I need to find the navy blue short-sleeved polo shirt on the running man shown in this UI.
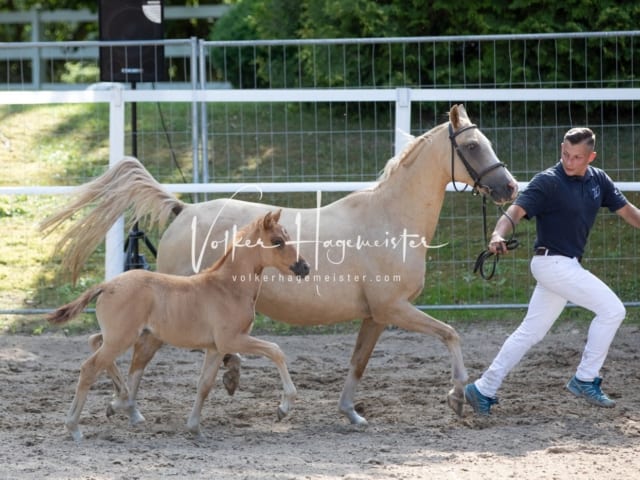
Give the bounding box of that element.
[514,162,627,258]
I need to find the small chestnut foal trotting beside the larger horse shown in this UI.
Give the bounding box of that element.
[48,212,309,441]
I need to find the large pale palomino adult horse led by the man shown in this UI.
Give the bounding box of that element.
[42,105,518,424]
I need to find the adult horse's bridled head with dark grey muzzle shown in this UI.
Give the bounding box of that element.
[449,105,518,204]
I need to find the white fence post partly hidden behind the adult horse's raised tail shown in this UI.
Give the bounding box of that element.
[104,84,125,280]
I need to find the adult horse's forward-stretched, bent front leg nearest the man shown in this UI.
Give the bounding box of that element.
[374,302,469,416]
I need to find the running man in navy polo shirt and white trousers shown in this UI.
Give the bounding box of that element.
[465,128,640,415]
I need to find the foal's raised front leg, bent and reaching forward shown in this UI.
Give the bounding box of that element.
[224,334,297,420]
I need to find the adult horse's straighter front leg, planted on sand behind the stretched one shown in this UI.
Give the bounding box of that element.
[338,318,385,425]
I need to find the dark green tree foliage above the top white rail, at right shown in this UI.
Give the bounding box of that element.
[210,0,640,88]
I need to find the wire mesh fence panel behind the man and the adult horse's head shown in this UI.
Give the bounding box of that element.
[201,32,640,308]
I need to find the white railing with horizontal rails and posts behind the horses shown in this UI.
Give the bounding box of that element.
[0,84,640,284]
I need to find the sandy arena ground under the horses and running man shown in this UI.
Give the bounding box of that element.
[0,322,640,480]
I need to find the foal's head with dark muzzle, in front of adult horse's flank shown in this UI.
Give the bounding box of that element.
[259,210,310,278]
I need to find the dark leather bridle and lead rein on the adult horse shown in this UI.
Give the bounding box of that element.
[449,122,518,280]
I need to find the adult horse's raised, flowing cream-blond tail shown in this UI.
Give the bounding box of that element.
[40,157,185,283]
